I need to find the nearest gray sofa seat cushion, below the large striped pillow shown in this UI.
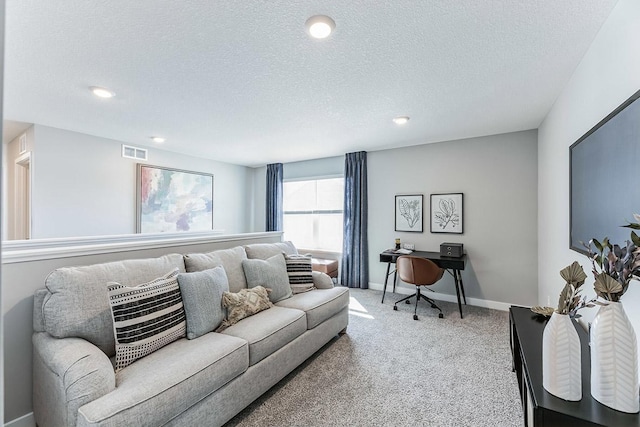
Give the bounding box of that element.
[78,333,249,426]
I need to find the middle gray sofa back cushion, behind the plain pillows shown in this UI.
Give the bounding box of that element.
[184,246,247,292]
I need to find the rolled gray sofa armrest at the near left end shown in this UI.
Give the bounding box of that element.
[32,332,116,427]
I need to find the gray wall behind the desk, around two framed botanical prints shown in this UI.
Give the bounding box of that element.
[367,130,537,306]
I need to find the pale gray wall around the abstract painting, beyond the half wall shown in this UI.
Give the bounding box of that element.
[32,124,252,239]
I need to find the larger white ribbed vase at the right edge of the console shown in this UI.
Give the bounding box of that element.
[591,302,640,414]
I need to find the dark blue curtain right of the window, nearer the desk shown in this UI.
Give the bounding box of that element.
[340,151,369,289]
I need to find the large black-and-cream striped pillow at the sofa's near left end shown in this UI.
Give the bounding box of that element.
[107,268,187,372]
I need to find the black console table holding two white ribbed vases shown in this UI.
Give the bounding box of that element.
[509,306,640,427]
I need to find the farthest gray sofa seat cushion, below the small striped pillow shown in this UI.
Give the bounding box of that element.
[276,286,349,329]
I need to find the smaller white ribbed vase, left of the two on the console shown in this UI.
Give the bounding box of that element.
[542,313,582,401]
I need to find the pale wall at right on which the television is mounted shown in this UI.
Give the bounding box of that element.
[538,0,640,333]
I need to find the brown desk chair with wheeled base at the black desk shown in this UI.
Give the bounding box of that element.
[393,255,444,320]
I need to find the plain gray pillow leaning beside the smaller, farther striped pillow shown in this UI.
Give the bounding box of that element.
[242,254,292,302]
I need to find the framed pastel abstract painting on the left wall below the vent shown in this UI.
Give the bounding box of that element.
[136,164,213,233]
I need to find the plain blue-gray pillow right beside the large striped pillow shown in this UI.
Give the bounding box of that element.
[178,267,229,340]
